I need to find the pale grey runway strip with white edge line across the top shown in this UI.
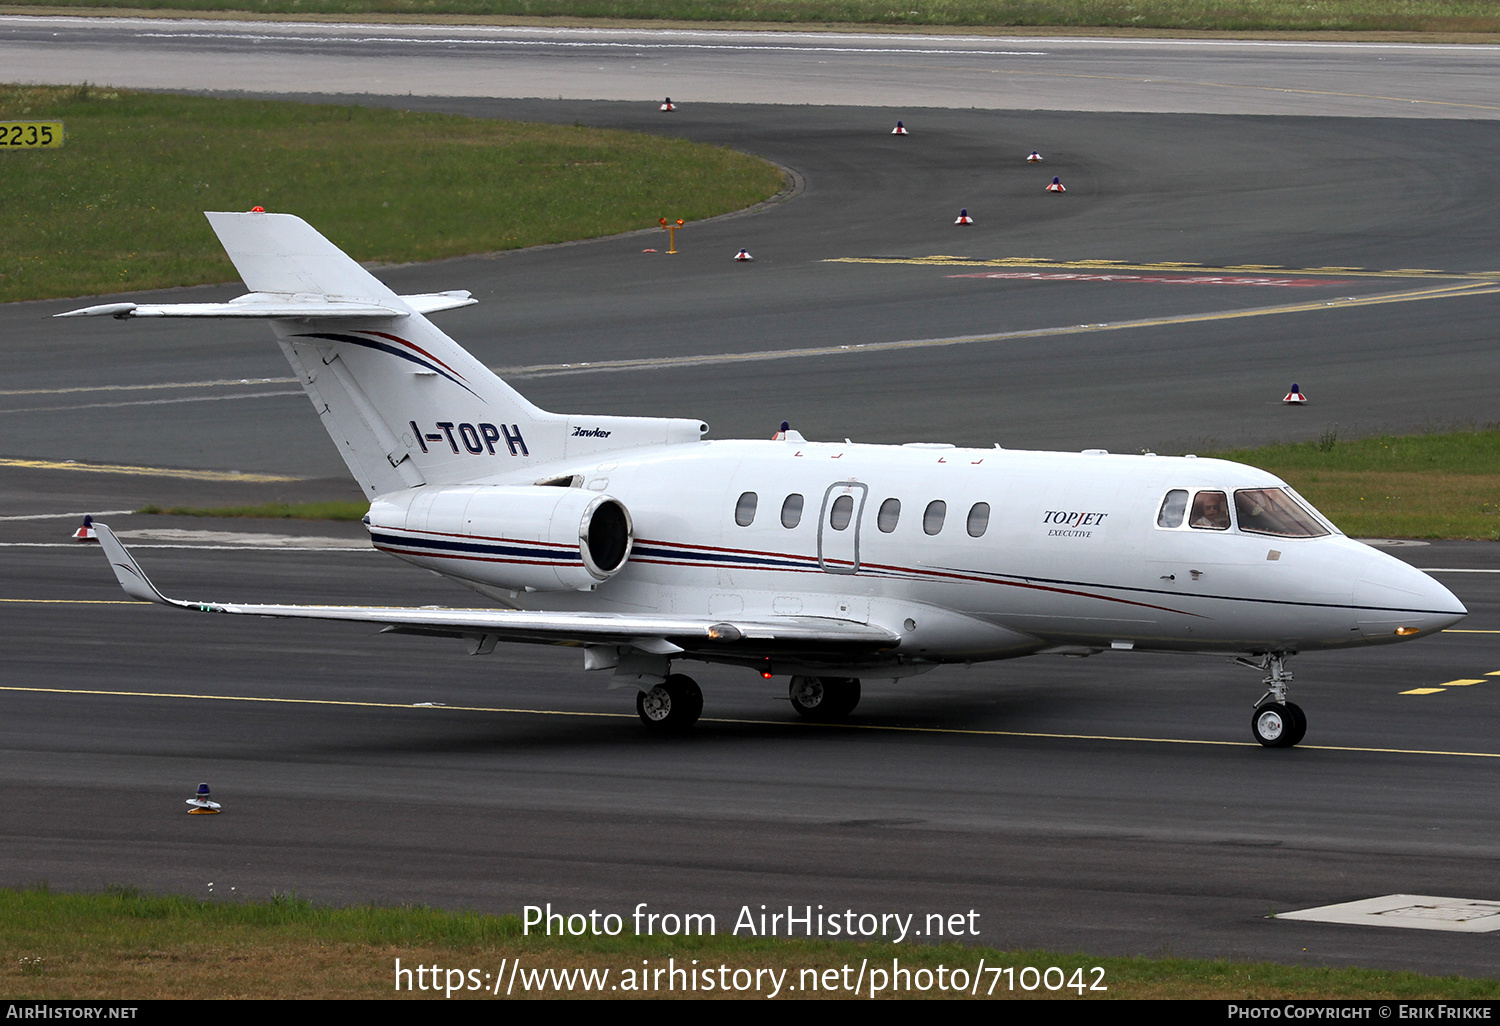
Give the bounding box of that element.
[0,17,1500,120]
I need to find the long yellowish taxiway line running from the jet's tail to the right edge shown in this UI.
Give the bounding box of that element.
[491,279,1500,378]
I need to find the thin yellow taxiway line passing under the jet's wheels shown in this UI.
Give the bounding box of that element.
[0,687,1500,759]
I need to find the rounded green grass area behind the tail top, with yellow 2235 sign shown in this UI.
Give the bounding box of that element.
[0,86,783,302]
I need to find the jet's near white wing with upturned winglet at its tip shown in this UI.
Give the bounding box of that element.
[93,522,900,659]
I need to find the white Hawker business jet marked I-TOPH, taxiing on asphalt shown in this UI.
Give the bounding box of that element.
[59,212,1467,747]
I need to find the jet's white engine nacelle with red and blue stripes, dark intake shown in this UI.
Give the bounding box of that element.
[375,485,635,591]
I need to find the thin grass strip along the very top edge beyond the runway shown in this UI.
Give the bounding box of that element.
[6,0,1500,33]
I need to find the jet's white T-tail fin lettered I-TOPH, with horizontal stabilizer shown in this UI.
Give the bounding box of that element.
[65,212,708,498]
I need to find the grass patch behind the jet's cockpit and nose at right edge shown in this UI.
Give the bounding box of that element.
[1214,425,1500,542]
